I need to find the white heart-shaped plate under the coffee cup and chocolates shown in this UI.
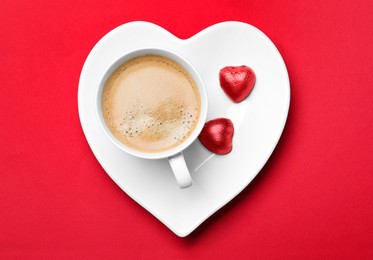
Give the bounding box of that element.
[78,22,290,237]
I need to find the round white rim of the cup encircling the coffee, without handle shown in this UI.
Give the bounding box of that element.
[96,48,207,159]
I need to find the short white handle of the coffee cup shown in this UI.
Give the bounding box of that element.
[168,152,192,189]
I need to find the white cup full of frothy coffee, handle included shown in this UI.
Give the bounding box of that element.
[96,48,207,188]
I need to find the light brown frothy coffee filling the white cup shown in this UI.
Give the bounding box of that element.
[102,55,201,152]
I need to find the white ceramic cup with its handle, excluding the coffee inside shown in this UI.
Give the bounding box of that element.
[96,48,207,188]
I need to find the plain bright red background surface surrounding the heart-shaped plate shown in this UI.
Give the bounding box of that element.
[0,0,373,259]
